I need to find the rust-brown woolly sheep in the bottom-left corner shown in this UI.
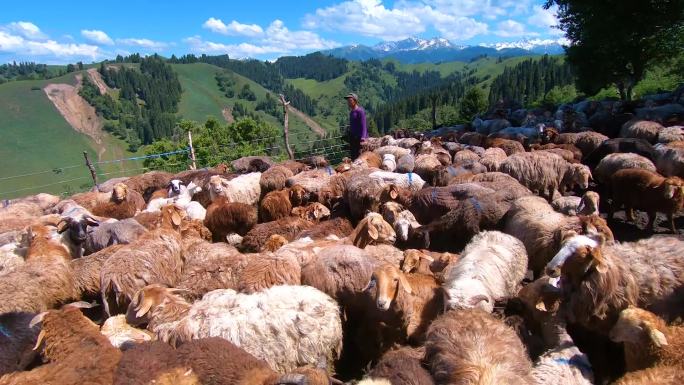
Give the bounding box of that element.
[0,304,121,385]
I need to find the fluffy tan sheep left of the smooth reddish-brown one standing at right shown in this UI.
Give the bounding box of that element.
[500,152,591,201]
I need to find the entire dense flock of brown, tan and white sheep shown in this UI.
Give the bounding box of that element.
[0,94,684,385]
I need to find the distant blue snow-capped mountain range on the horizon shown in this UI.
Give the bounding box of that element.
[323,37,564,63]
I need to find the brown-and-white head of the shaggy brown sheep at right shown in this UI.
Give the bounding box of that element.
[546,228,607,287]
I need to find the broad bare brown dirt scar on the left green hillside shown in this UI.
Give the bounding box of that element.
[43,75,106,159]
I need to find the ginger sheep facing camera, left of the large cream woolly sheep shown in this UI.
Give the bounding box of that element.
[363,263,444,343]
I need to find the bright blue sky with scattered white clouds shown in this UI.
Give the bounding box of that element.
[0,0,562,63]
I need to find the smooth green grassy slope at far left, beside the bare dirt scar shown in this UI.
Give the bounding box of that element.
[0,73,135,199]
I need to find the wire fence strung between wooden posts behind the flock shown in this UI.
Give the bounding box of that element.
[0,126,349,201]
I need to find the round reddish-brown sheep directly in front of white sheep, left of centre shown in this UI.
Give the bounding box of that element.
[204,197,258,242]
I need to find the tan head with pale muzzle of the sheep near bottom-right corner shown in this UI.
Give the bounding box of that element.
[609,306,667,348]
